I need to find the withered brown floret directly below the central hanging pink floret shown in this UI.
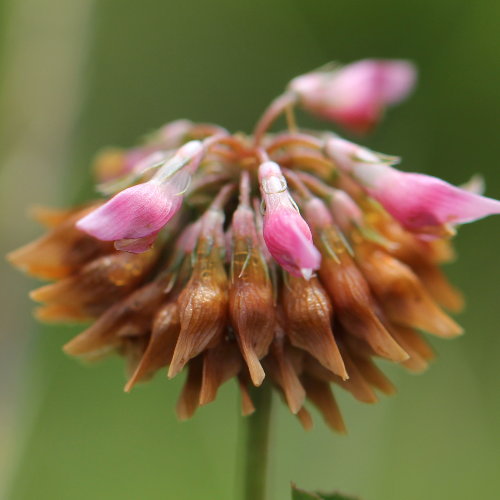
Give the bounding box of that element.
[282,276,349,379]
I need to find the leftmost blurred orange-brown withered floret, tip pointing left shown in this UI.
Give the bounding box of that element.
[7,204,114,280]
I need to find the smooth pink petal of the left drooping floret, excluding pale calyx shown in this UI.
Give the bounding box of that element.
[77,181,182,241]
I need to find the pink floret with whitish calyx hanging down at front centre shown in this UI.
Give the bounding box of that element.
[259,161,321,279]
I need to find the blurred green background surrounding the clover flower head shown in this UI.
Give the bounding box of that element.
[0,0,500,500]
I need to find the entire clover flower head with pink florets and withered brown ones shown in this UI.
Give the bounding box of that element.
[9,60,500,432]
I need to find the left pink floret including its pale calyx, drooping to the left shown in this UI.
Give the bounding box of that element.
[77,141,203,253]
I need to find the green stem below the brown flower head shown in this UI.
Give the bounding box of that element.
[243,383,272,500]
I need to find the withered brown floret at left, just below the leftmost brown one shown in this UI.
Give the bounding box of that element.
[30,250,158,321]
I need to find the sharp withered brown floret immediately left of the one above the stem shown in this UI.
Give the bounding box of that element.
[168,240,228,378]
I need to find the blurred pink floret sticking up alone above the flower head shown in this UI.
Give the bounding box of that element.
[289,59,416,132]
